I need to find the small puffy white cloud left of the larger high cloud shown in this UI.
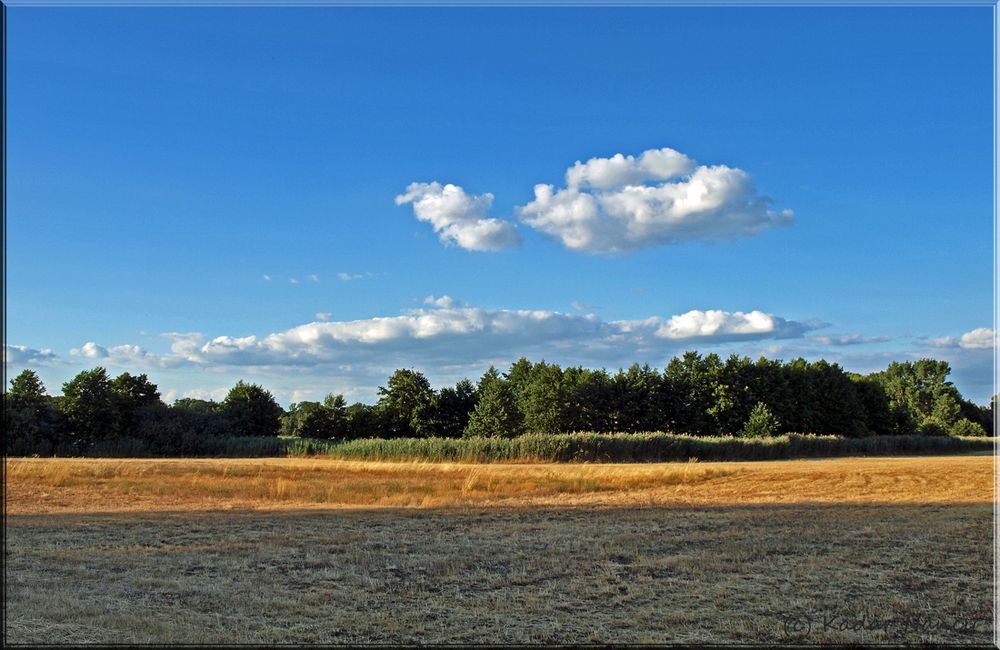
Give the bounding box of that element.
[396,181,521,251]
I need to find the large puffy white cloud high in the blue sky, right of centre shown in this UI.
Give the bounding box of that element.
[516,149,792,253]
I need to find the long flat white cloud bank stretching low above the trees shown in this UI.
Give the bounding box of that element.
[68,304,822,374]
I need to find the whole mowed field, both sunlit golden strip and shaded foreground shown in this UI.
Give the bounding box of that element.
[5,455,994,645]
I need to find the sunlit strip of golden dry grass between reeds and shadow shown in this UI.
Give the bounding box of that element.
[6,456,993,514]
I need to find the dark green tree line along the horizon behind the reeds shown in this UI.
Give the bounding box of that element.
[4,352,995,455]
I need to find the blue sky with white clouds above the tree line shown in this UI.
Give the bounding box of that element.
[5,7,993,405]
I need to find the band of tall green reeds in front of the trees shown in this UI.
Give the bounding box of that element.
[37,432,994,463]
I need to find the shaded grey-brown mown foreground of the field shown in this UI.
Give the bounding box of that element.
[6,503,993,644]
